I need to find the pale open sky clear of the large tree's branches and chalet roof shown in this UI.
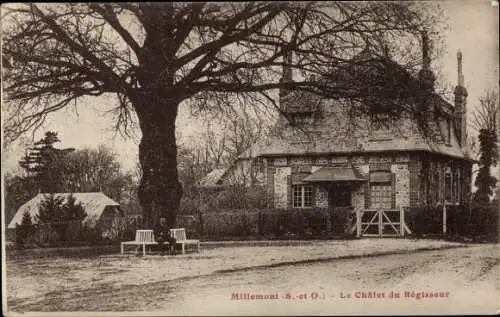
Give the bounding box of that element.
[2,0,500,172]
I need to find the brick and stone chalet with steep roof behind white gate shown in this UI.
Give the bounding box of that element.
[206,43,474,230]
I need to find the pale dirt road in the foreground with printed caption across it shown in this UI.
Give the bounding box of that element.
[10,245,500,315]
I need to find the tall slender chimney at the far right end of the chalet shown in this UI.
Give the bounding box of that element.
[454,50,467,146]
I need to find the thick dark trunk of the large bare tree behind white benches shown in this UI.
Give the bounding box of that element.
[138,94,182,229]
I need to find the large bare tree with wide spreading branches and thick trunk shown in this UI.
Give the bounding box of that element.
[2,2,438,226]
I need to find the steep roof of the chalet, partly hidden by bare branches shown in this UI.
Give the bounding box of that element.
[234,52,473,160]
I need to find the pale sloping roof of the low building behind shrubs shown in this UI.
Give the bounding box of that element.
[7,192,123,229]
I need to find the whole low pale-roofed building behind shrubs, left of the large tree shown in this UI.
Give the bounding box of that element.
[7,192,125,238]
